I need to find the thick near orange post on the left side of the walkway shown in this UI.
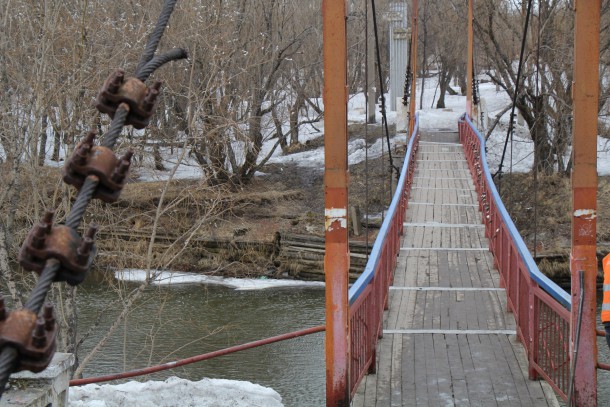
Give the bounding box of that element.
[322,0,350,407]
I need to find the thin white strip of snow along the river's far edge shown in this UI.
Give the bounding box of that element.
[114,269,324,290]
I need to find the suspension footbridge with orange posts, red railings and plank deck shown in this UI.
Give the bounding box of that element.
[2,0,609,407]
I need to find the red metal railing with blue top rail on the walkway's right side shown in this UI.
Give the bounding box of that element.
[459,116,571,400]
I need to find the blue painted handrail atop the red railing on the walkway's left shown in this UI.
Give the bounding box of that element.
[349,114,419,305]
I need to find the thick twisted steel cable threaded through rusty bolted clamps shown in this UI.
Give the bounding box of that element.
[0,0,187,397]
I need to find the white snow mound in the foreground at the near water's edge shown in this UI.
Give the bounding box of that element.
[68,377,283,407]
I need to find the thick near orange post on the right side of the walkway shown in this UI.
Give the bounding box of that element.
[570,0,601,406]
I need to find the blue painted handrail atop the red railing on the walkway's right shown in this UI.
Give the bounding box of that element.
[460,115,572,310]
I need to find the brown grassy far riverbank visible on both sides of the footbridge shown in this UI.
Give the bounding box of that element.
[83,133,610,287]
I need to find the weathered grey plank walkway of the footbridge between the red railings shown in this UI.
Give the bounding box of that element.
[352,132,558,407]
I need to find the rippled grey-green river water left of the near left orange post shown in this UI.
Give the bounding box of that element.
[79,279,325,406]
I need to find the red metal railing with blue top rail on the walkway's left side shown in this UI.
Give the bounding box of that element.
[349,116,419,396]
